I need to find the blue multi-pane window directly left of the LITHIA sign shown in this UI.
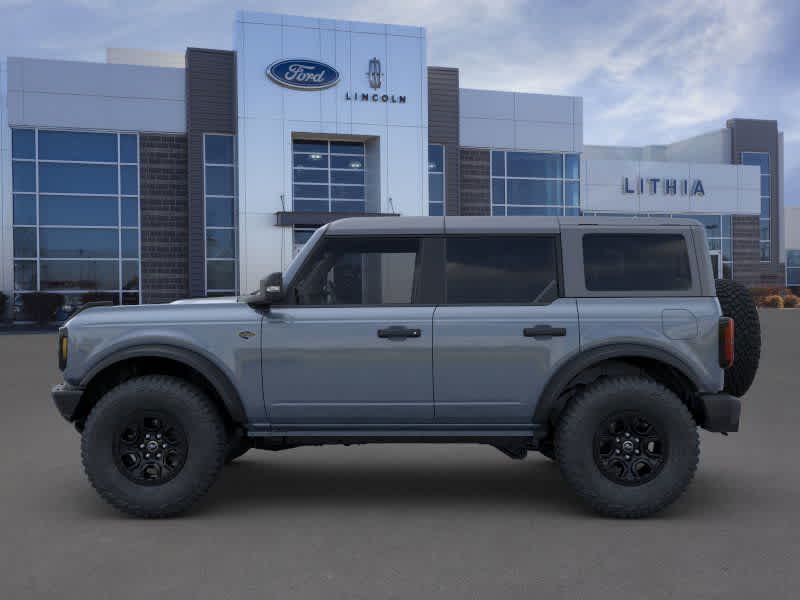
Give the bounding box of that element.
[491,150,581,216]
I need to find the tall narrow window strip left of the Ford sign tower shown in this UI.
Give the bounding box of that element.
[203,134,239,296]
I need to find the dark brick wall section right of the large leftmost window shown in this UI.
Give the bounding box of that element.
[139,133,189,304]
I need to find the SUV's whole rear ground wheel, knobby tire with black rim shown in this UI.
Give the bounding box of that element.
[556,377,700,518]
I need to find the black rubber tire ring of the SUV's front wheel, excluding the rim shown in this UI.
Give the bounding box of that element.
[81,375,227,518]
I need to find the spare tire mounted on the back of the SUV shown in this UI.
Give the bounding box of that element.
[715,279,761,396]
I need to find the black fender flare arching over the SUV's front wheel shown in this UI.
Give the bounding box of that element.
[81,344,247,423]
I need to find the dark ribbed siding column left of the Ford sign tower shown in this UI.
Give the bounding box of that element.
[186,48,237,297]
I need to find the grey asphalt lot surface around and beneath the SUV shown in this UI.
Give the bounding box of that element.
[0,310,800,600]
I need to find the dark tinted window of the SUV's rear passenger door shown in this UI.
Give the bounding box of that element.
[446,237,558,304]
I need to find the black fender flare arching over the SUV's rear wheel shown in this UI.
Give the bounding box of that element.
[533,343,702,425]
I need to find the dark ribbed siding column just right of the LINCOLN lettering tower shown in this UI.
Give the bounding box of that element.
[428,67,461,215]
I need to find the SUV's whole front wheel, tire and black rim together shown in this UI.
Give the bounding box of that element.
[81,375,228,518]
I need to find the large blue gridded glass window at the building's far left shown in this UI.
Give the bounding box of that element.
[11,128,141,320]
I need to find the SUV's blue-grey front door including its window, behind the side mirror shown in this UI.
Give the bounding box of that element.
[262,237,434,427]
